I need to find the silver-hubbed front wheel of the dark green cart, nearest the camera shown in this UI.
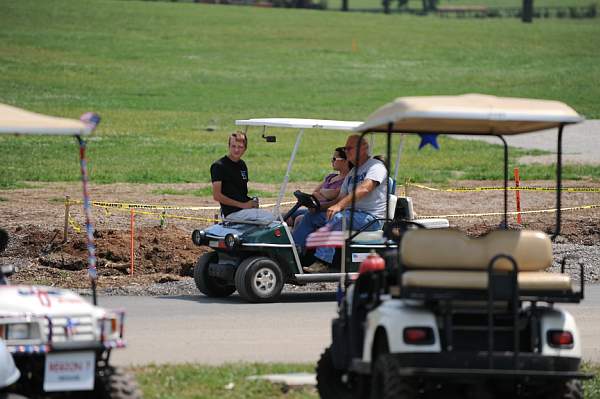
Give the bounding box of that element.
[235,256,283,302]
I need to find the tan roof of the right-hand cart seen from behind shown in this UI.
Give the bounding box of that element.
[355,94,584,135]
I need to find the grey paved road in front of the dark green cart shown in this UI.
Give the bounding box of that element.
[100,285,600,365]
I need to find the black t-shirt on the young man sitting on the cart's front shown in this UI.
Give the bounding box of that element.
[210,156,251,216]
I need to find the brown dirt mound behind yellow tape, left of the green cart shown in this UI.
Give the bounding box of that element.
[4,225,206,288]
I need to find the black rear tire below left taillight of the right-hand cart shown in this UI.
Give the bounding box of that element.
[371,354,419,399]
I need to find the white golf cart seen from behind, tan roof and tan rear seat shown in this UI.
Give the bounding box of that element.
[317,94,590,399]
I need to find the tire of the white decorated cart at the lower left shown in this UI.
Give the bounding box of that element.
[94,367,142,399]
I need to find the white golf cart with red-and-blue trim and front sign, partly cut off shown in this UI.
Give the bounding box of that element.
[0,104,141,398]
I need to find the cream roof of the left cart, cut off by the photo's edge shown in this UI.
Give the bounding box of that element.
[0,104,94,135]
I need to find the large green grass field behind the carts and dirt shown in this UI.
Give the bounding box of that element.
[0,0,600,187]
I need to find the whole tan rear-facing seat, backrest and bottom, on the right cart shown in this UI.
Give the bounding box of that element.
[397,229,580,302]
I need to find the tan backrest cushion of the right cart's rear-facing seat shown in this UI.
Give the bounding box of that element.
[401,229,552,271]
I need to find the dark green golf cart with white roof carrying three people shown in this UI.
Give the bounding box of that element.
[192,118,448,302]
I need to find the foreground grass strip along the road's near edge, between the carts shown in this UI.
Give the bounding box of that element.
[134,364,600,399]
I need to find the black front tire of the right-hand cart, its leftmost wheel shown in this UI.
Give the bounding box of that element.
[317,348,367,399]
